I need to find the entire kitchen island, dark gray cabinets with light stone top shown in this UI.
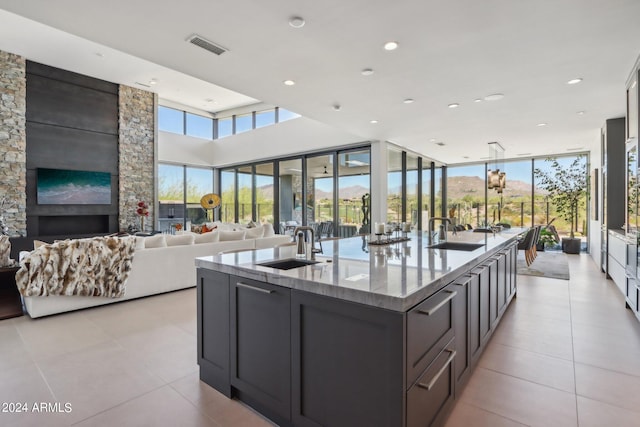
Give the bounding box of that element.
[196,229,522,427]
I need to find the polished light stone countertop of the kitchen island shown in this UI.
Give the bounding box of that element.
[195,228,526,312]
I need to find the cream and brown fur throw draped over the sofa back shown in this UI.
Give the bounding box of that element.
[16,236,136,298]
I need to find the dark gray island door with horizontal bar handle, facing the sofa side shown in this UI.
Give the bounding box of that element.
[231,276,291,421]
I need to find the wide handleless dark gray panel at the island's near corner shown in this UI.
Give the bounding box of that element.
[291,290,405,427]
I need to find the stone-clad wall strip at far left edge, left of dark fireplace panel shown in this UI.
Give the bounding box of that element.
[0,51,27,236]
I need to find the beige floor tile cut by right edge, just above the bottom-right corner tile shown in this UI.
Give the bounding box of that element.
[576,361,640,412]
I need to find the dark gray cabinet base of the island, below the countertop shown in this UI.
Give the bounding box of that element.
[197,241,517,427]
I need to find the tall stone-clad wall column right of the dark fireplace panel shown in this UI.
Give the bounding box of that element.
[118,85,155,231]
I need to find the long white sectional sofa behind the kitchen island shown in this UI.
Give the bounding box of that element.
[24,228,291,318]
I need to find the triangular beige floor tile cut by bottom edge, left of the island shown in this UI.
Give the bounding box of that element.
[76,386,219,427]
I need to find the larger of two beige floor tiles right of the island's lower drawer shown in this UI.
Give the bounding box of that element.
[461,367,577,427]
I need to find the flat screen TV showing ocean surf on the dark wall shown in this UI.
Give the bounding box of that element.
[37,169,111,205]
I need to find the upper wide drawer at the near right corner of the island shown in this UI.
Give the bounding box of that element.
[407,288,457,389]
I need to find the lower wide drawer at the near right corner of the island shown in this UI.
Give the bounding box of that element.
[407,342,456,427]
